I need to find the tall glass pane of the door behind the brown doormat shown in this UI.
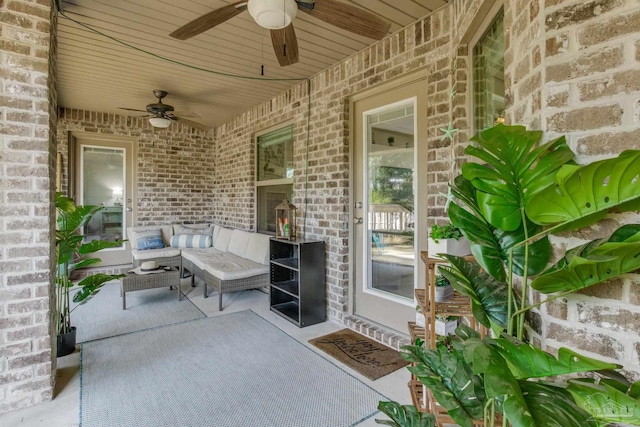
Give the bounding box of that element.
[366,101,415,301]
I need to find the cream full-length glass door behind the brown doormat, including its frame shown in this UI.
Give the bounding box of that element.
[352,80,426,334]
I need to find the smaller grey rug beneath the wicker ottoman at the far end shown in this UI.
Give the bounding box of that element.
[71,281,204,343]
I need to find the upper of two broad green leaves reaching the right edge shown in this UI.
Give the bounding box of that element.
[526,150,640,230]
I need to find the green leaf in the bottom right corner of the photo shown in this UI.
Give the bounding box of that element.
[567,380,640,426]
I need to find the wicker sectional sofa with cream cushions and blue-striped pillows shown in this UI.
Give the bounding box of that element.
[128,224,270,311]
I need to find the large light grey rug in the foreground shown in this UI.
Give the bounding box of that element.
[80,311,388,427]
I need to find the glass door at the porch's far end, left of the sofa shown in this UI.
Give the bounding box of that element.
[73,136,135,266]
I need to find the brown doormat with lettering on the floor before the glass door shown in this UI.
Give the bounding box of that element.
[309,329,409,381]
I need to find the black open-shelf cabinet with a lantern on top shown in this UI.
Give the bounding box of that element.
[269,238,327,327]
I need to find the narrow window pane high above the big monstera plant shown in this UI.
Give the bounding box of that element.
[473,11,504,132]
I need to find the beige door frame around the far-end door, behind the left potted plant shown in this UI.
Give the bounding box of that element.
[67,131,139,266]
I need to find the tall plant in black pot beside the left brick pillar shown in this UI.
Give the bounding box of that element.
[55,193,125,357]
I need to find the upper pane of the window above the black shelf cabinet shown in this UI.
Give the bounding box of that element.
[257,125,293,181]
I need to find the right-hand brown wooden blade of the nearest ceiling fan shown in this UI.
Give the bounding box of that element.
[300,0,391,40]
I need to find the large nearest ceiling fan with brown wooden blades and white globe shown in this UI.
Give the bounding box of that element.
[169,0,391,67]
